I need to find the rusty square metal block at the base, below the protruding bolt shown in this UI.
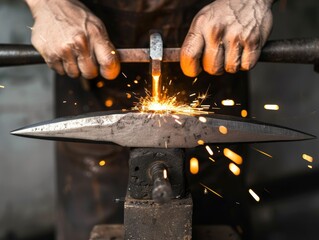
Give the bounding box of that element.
[124,197,193,240]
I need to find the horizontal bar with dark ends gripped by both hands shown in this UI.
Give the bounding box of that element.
[0,38,319,67]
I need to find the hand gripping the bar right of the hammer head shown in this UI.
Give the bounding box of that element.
[181,0,274,77]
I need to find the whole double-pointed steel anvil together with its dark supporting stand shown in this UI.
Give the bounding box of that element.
[12,111,313,240]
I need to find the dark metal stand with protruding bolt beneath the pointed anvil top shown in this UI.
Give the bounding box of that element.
[90,148,193,240]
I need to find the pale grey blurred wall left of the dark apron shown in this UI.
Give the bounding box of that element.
[0,0,55,239]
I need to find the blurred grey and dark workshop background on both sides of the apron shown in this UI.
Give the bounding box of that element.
[0,0,319,240]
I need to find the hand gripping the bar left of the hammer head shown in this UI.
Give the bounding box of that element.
[25,0,120,79]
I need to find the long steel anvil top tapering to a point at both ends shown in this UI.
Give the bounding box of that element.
[12,111,314,148]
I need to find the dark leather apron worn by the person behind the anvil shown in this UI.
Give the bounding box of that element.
[55,0,248,240]
